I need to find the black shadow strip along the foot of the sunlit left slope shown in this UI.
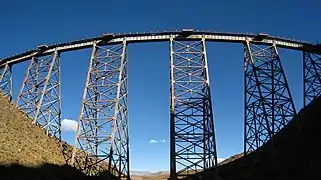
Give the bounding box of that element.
[0,163,117,180]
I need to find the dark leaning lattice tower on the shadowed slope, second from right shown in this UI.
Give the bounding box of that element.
[244,41,296,154]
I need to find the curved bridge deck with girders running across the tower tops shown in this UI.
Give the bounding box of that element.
[0,31,321,64]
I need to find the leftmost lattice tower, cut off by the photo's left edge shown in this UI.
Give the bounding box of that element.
[0,63,12,101]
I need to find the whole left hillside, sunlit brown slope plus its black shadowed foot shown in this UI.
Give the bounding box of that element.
[0,95,114,180]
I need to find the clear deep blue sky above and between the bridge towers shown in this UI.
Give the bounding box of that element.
[0,0,321,171]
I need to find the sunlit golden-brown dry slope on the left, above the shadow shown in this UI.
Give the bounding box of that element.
[0,95,65,166]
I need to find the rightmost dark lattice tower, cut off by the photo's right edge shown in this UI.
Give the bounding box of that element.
[303,52,321,106]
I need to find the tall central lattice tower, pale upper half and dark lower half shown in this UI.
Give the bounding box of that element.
[170,37,217,180]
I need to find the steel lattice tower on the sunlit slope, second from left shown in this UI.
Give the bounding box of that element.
[16,50,61,140]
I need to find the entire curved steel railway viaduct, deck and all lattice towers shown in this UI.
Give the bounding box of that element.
[0,29,321,179]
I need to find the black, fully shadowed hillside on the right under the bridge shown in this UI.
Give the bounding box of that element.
[184,95,321,180]
